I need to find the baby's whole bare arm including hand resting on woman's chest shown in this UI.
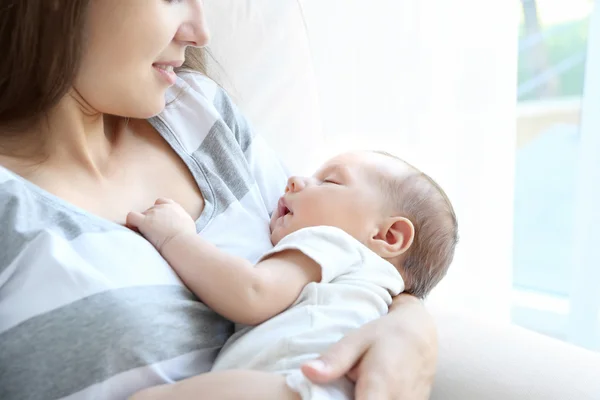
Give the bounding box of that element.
[127,199,321,325]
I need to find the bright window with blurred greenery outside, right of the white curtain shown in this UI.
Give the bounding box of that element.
[511,0,600,350]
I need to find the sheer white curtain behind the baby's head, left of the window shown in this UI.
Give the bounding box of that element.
[299,0,518,321]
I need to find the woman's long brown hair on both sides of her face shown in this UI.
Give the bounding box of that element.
[0,0,206,131]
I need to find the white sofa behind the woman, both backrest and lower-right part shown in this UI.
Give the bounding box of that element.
[205,0,600,400]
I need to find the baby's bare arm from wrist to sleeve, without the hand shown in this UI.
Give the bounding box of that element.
[161,234,320,325]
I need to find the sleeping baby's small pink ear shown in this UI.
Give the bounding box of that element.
[371,217,415,258]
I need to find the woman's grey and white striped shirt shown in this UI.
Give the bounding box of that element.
[0,73,286,399]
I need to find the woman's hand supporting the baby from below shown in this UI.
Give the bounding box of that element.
[302,294,437,400]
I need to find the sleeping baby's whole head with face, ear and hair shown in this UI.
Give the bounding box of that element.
[271,152,458,298]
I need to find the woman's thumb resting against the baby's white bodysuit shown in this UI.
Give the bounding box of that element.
[302,329,370,383]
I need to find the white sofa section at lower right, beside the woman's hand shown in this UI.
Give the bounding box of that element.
[431,307,600,400]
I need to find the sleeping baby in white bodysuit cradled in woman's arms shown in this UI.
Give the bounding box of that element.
[128,152,458,400]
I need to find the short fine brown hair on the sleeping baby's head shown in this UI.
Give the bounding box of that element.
[374,151,458,298]
